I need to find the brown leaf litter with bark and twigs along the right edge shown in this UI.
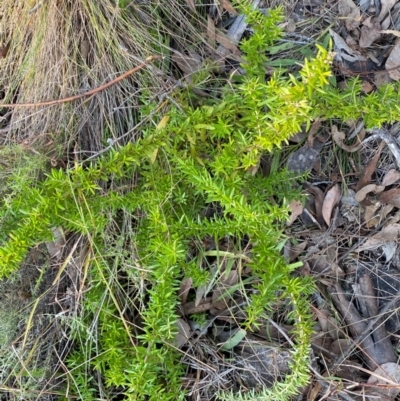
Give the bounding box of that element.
[285,0,400,400]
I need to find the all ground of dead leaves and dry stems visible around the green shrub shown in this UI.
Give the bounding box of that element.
[0,0,400,400]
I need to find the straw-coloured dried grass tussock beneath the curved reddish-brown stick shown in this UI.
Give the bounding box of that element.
[0,0,206,152]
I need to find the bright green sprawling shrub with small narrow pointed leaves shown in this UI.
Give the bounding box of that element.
[0,1,399,400]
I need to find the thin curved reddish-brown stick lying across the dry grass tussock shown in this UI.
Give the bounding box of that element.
[0,56,161,108]
